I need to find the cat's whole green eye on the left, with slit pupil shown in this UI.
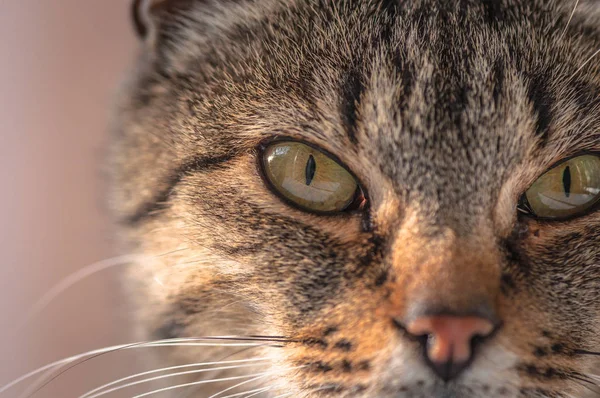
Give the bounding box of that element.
[262,141,361,213]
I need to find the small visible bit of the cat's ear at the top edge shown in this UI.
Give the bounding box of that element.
[131,0,192,40]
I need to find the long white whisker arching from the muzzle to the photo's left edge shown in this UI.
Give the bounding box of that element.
[0,336,288,394]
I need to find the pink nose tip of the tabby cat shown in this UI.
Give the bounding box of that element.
[406,315,495,381]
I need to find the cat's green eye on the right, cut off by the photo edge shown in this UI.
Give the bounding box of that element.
[521,155,600,219]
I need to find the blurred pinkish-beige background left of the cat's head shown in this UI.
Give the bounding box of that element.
[0,0,144,398]
